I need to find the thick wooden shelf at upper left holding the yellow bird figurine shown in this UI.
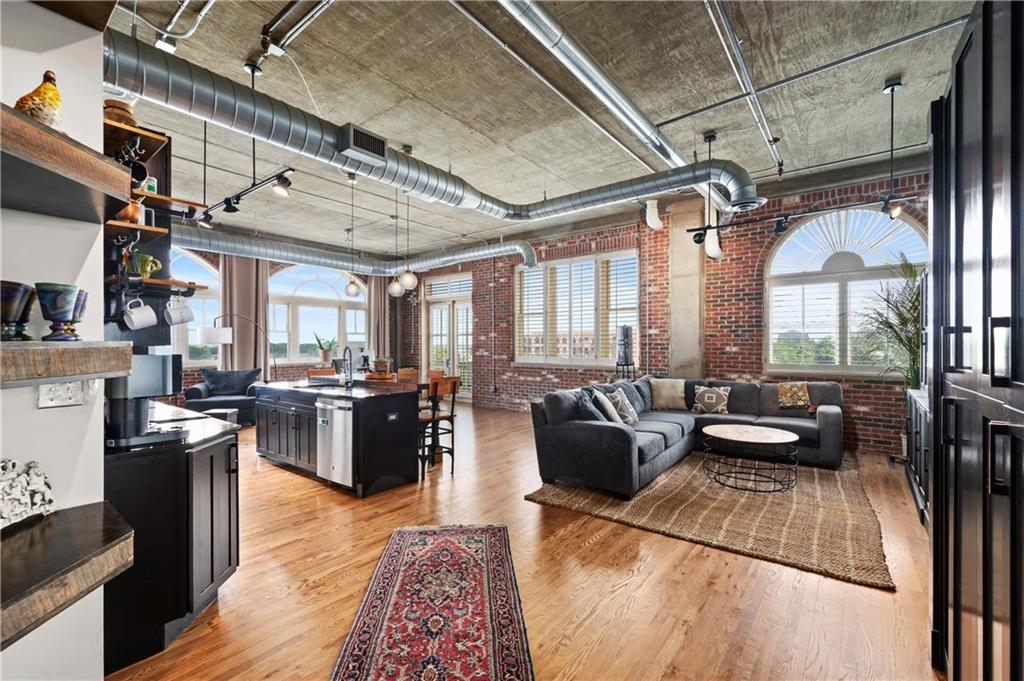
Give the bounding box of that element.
[0,104,131,224]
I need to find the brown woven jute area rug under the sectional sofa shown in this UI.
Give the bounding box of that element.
[526,452,896,591]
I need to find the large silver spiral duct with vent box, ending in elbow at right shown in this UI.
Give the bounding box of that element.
[103,31,764,220]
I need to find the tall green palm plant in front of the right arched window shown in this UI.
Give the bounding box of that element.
[862,253,924,458]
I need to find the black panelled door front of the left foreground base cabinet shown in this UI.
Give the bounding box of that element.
[188,435,239,610]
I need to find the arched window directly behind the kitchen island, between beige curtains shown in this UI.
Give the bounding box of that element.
[267,265,367,361]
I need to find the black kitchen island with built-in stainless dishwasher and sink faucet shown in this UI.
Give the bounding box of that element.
[256,377,419,498]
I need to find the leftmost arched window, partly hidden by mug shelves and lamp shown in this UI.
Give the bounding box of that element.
[171,248,220,365]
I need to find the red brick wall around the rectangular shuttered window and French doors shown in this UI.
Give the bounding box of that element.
[401,216,669,410]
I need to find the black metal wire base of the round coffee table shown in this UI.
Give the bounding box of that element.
[703,436,797,494]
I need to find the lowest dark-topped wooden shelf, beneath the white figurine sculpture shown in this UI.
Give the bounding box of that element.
[0,502,135,649]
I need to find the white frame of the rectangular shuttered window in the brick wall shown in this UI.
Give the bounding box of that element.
[512,249,643,369]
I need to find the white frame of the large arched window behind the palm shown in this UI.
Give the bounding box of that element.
[762,209,928,377]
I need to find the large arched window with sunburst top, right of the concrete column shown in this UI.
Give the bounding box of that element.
[765,210,928,373]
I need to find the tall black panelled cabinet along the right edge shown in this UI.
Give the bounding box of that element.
[929,2,1024,681]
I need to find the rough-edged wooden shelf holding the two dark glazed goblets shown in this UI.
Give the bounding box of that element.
[0,341,131,388]
